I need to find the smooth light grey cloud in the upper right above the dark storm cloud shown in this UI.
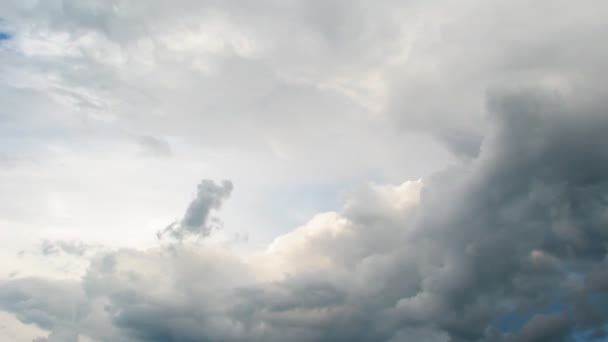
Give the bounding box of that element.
[387,0,608,157]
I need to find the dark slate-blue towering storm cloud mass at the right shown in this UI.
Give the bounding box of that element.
[392,90,608,341]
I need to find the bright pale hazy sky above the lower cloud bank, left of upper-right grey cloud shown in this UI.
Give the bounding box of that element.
[0,1,466,276]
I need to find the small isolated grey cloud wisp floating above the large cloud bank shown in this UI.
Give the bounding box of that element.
[157,179,233,240]
